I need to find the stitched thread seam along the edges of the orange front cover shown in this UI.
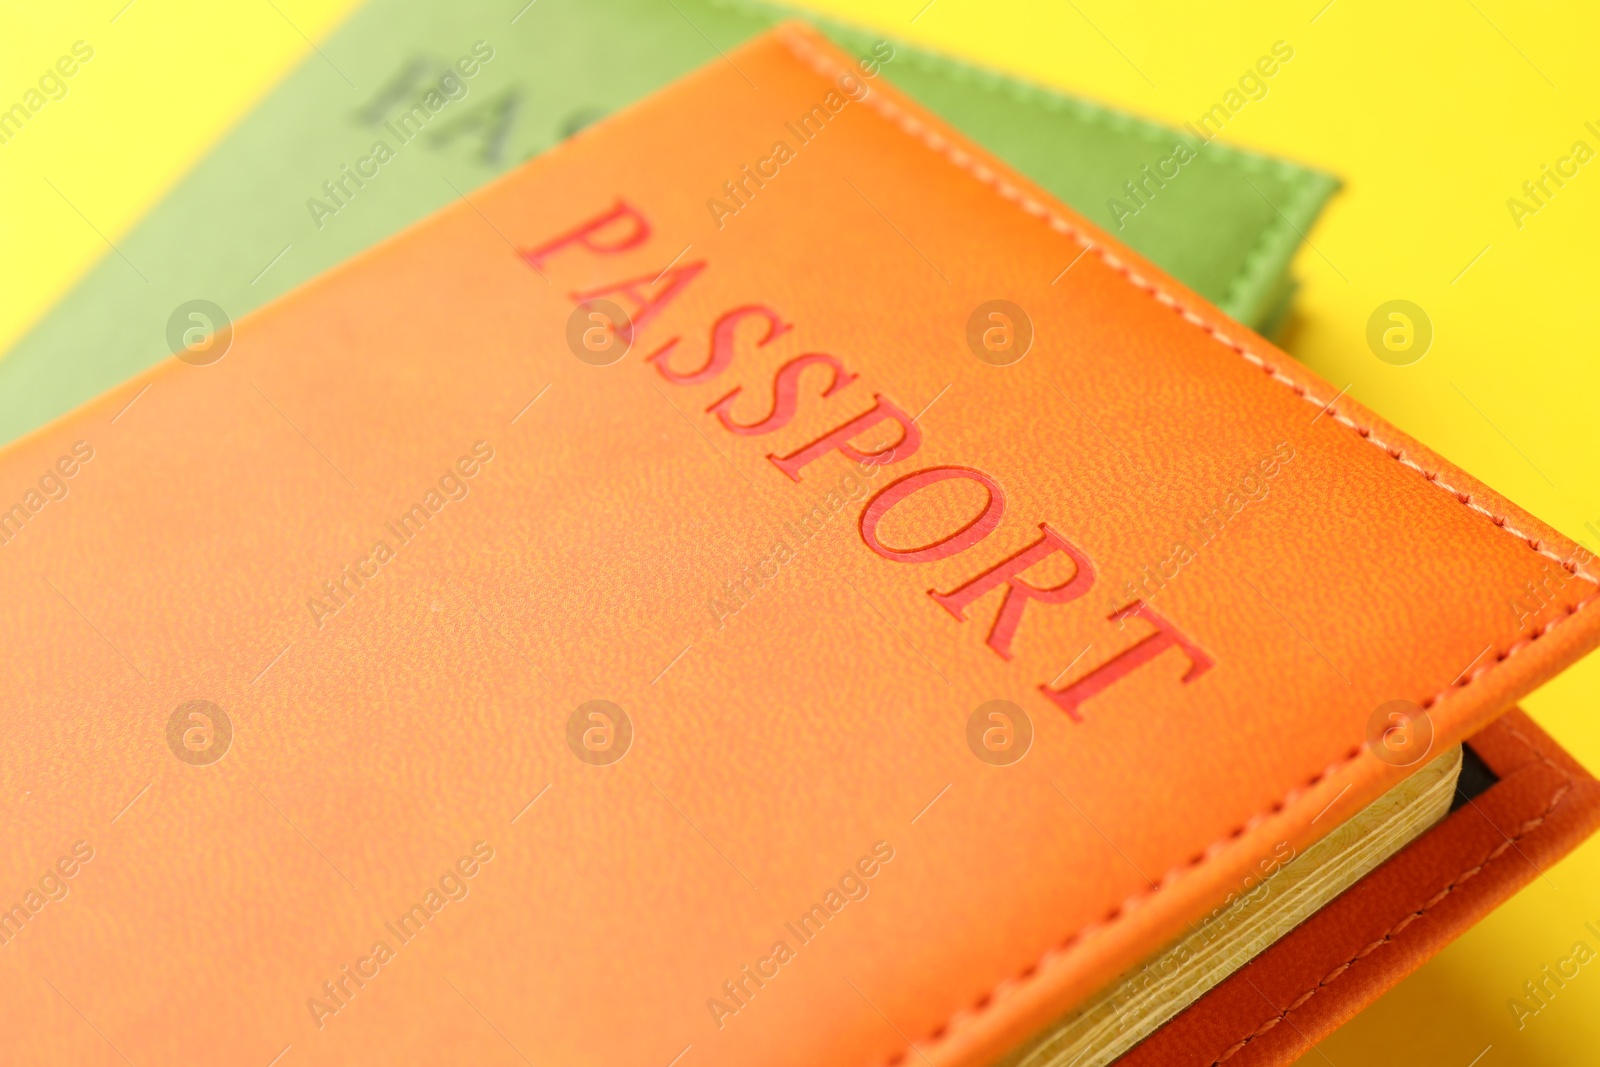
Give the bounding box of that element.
[761,29,1600,1067]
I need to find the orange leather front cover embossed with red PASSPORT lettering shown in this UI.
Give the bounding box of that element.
[0,26,1600,1067]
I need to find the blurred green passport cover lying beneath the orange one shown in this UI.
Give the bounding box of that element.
[0,0,1336,442]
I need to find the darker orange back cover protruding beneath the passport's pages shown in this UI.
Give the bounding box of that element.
[1118,709,1600,1067]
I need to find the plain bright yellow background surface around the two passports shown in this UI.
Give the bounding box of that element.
[0,0,1600,1067]
